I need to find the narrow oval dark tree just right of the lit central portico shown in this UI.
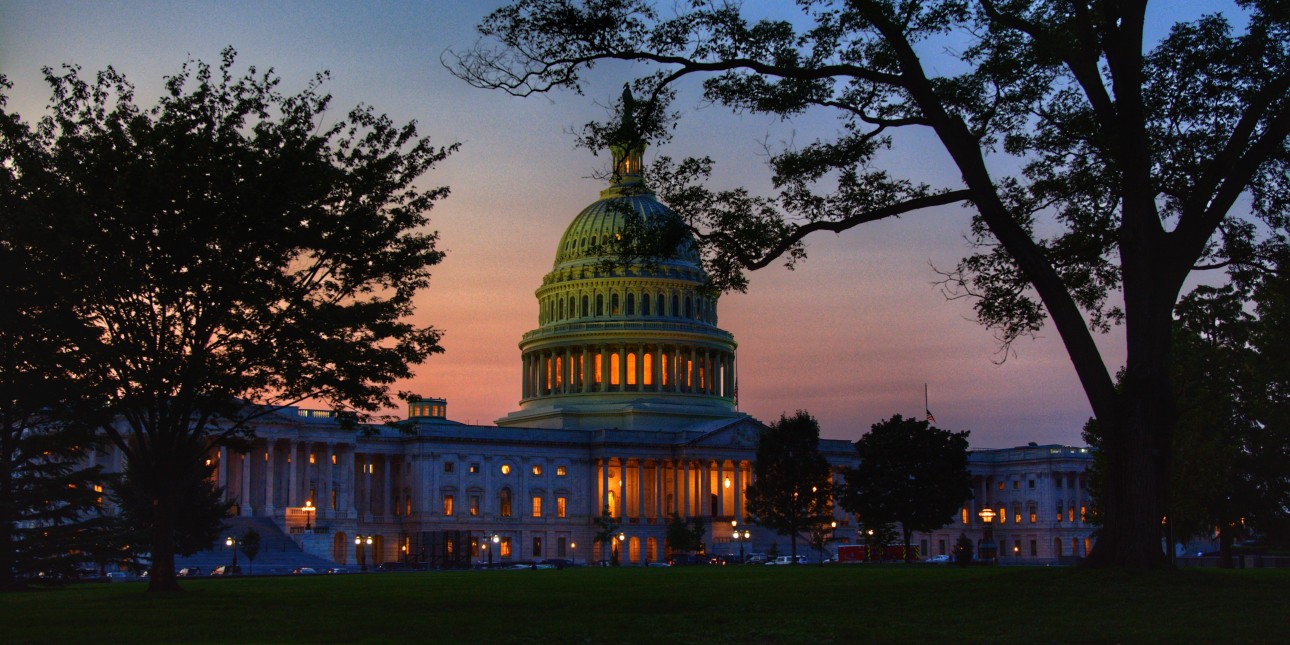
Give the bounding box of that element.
[744,410,833,564]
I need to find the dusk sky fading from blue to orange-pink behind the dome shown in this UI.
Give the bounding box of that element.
[0,0,1226,448]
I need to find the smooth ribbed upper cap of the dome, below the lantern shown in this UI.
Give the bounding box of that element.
[555,190,699,270]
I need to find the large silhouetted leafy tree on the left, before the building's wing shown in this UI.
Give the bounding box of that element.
[0,49,455,591]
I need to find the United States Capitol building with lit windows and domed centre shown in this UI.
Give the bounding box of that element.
[95,133,1091,566]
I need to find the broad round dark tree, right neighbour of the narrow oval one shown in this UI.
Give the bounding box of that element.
[839,414,971,561]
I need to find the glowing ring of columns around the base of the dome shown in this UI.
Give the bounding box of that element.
[522,344,734,399]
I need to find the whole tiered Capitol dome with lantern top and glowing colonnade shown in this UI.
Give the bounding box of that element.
[498,121,742,430]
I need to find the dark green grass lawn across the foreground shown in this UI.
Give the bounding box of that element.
[0,565,1290,645]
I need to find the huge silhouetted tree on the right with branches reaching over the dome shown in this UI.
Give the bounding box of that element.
[446,0,1290,568]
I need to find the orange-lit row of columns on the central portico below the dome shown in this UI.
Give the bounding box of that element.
[593,458,752,520]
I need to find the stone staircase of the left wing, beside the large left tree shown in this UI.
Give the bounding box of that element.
[174,517,335,575]
